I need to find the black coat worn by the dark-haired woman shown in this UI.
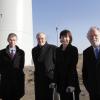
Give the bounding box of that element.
[54,44,80,92]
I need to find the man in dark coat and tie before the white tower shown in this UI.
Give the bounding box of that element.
[0,33,25,100]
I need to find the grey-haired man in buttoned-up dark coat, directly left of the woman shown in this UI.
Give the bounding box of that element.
[32,33,56,100]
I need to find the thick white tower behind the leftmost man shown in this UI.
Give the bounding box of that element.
[0,0,33,66]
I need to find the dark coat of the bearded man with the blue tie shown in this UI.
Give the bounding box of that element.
[82,46,100,95]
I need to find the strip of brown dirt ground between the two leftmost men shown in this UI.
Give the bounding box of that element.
[21,67,35,100]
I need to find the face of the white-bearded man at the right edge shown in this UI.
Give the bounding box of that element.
[89,29,100,47]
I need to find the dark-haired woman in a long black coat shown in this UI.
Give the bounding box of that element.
[55,30,80,100]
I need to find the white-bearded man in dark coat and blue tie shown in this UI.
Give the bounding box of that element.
[82,27,100,100]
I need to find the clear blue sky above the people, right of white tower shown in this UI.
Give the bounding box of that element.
[33,0,100,53]
